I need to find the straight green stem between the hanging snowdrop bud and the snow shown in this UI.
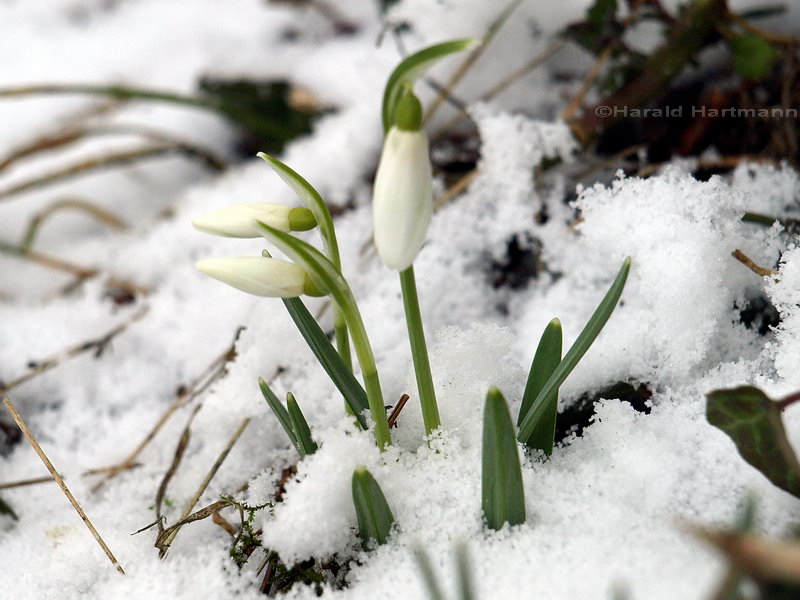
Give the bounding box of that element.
[400,265,441,435]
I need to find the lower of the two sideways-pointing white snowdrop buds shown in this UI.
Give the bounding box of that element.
[195,256,324,298]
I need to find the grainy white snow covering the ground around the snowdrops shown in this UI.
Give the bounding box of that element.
[0,0,800,600]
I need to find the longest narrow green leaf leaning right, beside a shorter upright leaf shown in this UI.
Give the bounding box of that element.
[519,257,631,441]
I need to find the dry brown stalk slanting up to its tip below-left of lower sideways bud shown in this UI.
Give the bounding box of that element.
[84,327,244,492]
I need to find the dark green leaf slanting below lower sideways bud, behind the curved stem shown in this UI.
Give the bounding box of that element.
[283,298,369,429]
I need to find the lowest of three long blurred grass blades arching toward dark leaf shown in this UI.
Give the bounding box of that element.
[0,144,219,201]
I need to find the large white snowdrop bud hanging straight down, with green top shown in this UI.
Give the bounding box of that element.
[372,91,433,271]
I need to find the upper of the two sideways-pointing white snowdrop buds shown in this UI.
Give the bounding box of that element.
[192,202,317,238]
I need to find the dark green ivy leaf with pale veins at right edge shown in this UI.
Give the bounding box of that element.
[706,386,800,497]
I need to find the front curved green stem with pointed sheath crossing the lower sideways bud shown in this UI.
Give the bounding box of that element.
[258,221,392,448]
